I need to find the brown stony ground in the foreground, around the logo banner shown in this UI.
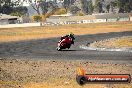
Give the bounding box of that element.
[0,58,132,88]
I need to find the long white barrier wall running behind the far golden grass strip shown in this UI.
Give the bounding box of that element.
[0,17,132,28]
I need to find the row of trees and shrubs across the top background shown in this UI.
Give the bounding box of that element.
[0,0,132,17]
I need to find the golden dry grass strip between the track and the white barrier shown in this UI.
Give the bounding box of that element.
[0,22,132,42]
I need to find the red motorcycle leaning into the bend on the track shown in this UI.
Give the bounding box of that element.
[56,37,73,51]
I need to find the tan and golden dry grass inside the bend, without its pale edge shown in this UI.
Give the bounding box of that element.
[90,36,132,48]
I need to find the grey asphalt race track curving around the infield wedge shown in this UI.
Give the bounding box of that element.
[0,32,132,63]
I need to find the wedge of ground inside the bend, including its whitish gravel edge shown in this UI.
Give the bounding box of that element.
[80,36,132,52]
